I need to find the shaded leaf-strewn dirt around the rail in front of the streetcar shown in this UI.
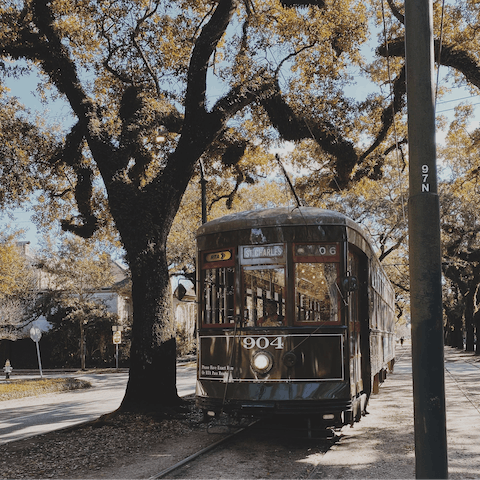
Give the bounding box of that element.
[0,397,333,480]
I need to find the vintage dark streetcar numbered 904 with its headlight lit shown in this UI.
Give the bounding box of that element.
[196,207,395,426]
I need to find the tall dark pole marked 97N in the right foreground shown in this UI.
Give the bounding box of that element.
[405,0,448,480]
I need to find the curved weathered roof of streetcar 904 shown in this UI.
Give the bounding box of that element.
[197,207,368,238]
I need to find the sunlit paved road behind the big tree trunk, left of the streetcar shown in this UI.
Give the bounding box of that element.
[0,366,196,443]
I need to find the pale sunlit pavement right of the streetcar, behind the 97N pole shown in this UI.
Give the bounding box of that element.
[308,345,480,480]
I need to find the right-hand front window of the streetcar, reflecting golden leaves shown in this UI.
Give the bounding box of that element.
[295,262,339,323]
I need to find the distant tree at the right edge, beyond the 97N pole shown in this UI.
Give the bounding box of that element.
[439,106,480,354]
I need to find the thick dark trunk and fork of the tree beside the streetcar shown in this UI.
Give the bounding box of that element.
[109,133,205,412]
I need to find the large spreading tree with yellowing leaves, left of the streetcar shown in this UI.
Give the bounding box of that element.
[0,0,476,410]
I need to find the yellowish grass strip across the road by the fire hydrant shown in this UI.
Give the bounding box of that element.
[0,378,92,401]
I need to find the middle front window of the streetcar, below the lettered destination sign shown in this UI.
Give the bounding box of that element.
[243,265,285,327]
